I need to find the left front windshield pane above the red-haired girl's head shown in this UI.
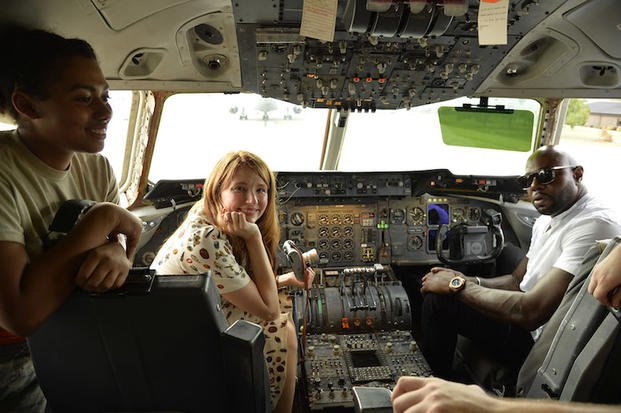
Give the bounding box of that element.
[149,93,329,182]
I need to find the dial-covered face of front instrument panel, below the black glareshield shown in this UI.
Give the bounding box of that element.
[280,194,504,267]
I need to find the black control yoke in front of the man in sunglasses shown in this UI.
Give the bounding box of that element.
[436,208,504,265]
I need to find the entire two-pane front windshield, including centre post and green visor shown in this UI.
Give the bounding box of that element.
[149,93,540,182]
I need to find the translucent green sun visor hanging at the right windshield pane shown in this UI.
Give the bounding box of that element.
[438,105,534,152]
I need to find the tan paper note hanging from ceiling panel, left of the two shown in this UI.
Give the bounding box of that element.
[300,0,338,42]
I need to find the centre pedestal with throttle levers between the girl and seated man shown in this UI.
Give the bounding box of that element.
[293,263,431,411]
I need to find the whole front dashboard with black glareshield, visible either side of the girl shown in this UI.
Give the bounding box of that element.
[136,170,523,268]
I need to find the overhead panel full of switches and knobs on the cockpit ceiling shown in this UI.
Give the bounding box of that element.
[233,0,563,112]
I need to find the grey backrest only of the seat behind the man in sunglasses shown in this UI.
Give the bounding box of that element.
[518,237,621,403]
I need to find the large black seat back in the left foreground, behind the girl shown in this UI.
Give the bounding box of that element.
[29,271,270,413]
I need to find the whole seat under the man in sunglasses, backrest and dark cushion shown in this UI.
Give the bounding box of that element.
[456,237,621,403]
